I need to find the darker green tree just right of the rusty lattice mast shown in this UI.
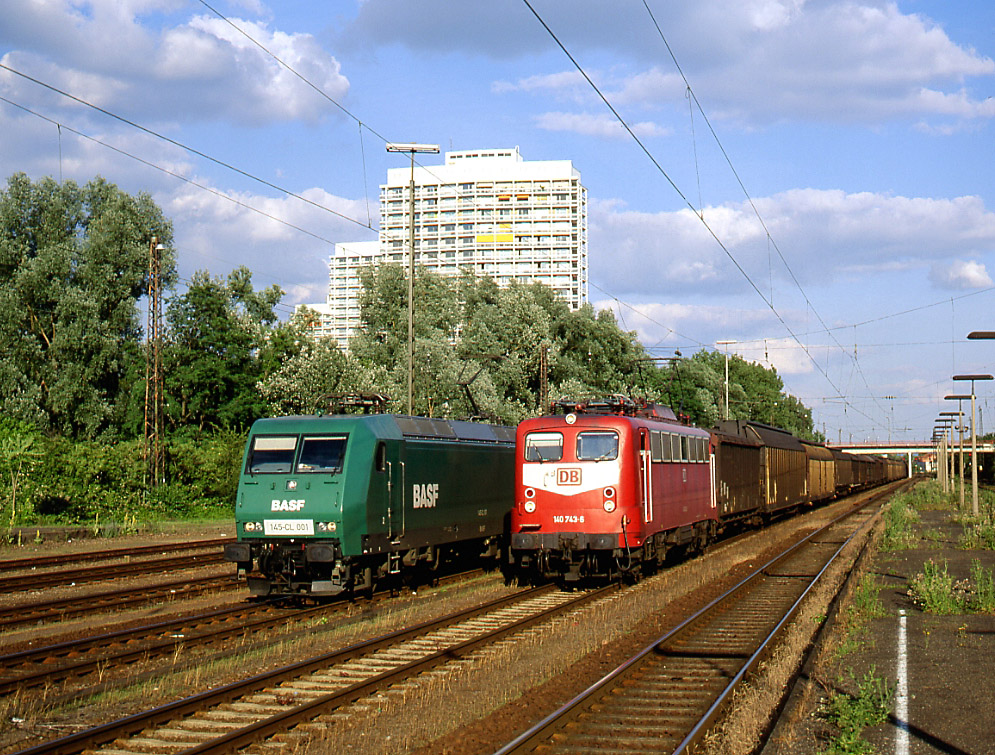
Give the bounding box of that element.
[163,267,282,431]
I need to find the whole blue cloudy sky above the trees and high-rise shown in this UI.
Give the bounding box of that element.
[0,0,995,441]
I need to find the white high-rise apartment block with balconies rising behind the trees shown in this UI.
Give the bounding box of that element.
[310,147,588,348]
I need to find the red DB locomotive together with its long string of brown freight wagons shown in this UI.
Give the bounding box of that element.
[510,396,905,582]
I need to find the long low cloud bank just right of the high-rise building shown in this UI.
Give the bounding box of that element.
[590,189,995,295]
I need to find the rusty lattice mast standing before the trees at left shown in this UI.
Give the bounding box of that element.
[145,236,166,489]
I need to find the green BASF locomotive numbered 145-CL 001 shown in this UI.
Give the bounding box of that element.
[225,414,515,597]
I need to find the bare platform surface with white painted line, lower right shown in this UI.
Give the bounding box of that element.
[763,502,995,755]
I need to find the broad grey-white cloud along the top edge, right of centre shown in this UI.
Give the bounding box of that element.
[364,0,995,129]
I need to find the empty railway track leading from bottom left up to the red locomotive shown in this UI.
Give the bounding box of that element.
[18,585,617,755]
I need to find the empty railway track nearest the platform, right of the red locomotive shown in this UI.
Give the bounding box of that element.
[495,484,908,755]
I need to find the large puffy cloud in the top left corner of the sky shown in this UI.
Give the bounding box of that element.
[0,0,349,125]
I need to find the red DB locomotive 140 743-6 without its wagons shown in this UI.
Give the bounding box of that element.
[511,396,718,581]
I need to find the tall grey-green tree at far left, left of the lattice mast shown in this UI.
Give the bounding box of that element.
[0,173,175,437]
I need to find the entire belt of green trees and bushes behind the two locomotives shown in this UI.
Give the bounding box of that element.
[0,174,824,528]
